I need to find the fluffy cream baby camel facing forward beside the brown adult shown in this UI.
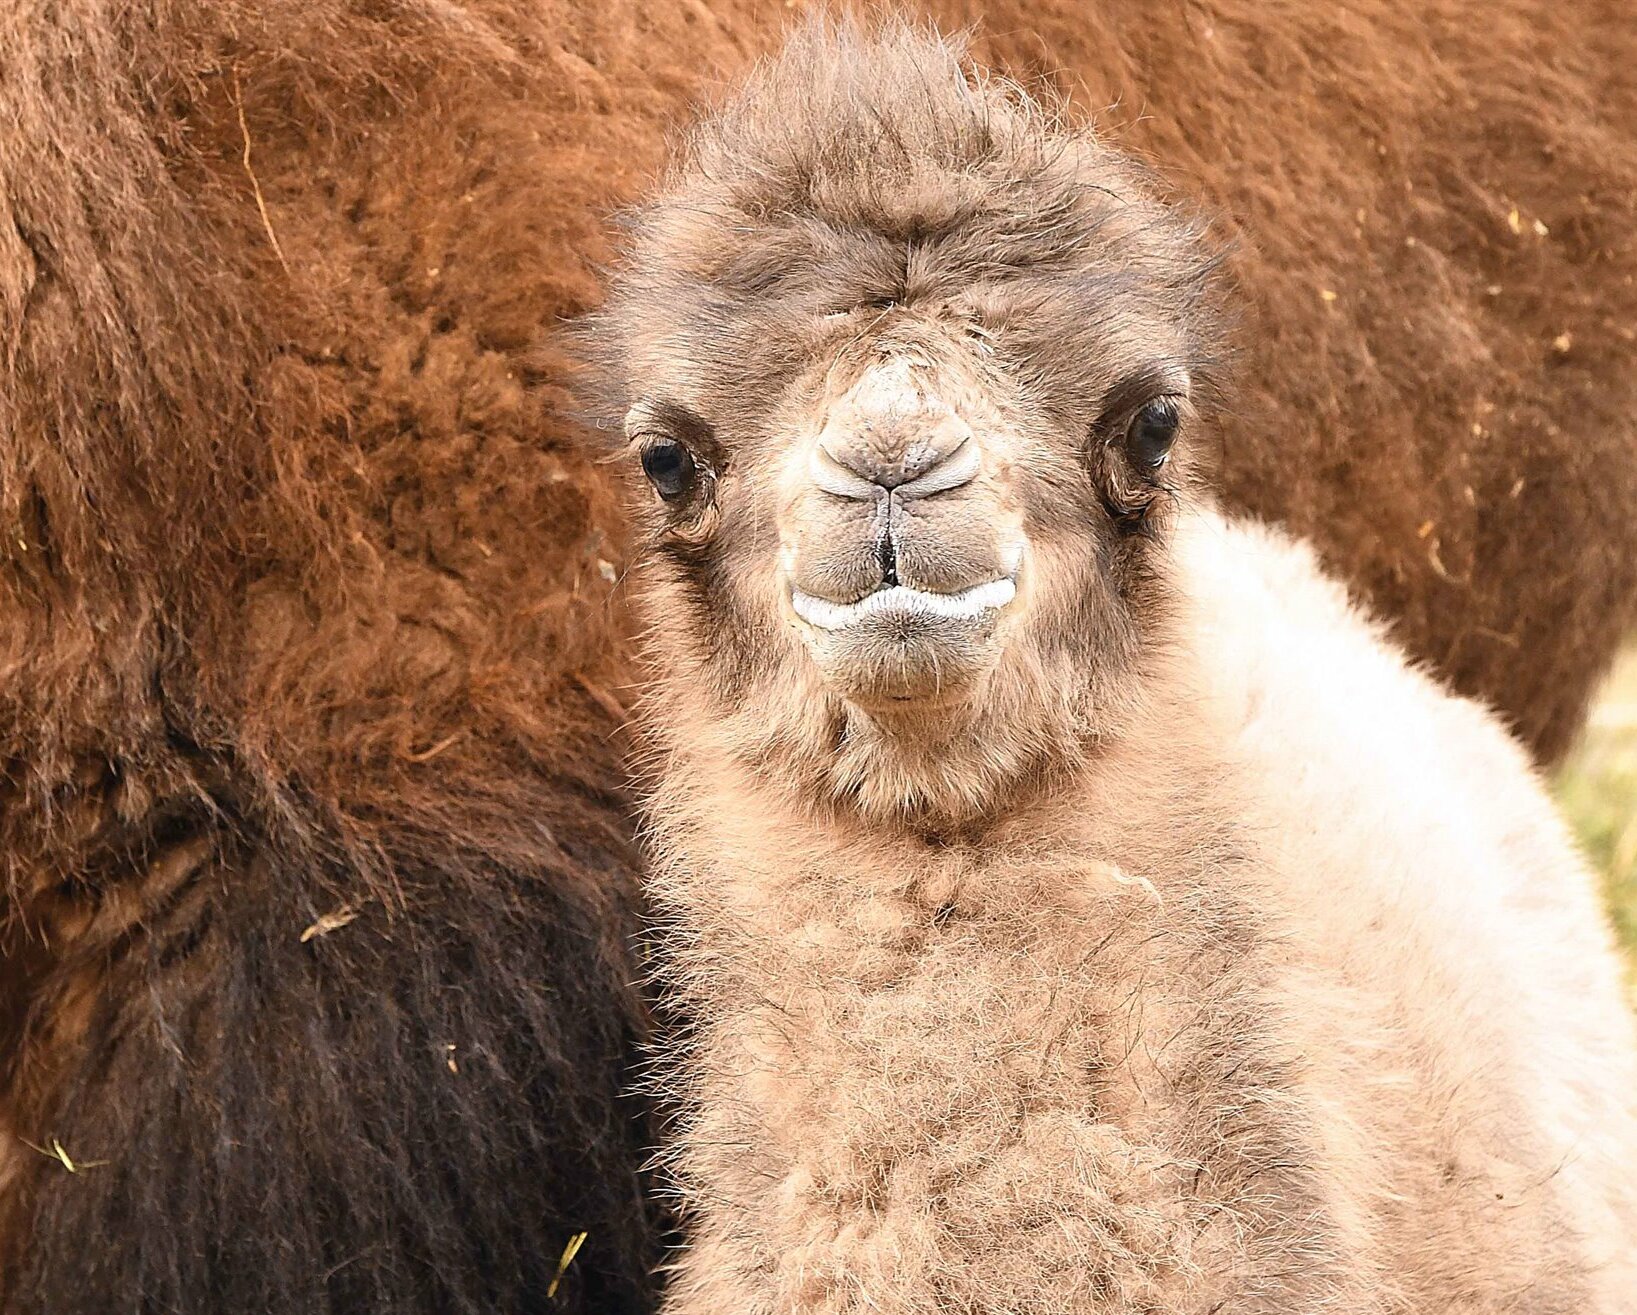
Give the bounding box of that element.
[596,23,1637,1315]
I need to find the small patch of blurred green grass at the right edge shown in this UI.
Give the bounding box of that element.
[1555,642,1637,999]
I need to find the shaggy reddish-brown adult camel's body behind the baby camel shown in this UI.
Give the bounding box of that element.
[0,0,1637,1313]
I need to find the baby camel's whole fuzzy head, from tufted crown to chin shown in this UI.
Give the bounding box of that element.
[594,23,1218,812]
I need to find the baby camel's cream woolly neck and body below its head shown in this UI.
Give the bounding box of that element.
[650,511,1637,1315]
